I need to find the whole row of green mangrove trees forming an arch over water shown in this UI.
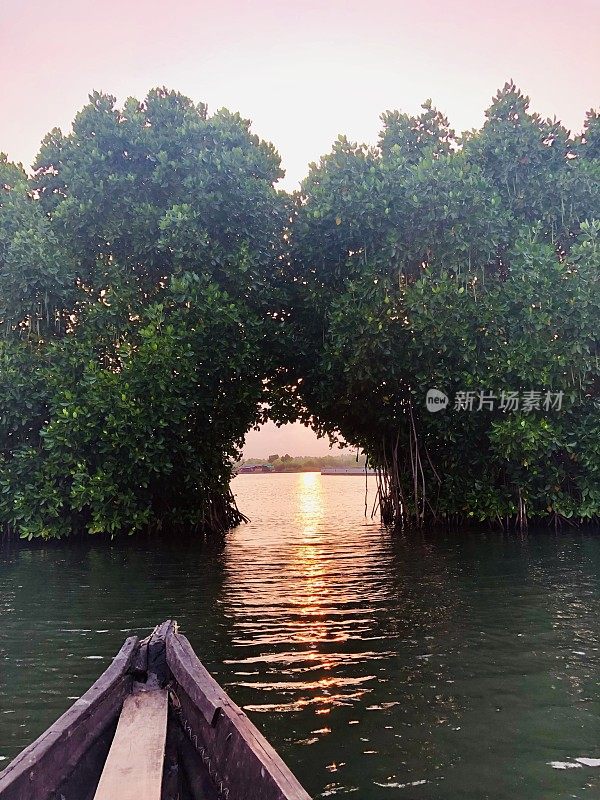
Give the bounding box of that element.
[0,83,600,538]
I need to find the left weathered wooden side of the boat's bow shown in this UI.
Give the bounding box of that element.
[0,636,138,800]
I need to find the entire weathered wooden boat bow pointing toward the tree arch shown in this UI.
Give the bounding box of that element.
[0,620,310,800]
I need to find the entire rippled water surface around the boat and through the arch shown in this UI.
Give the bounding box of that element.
[0,473,600,800]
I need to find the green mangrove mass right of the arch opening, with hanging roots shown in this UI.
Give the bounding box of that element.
[290,84,600,525]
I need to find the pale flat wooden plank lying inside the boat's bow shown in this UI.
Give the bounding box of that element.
[94,689,169,800]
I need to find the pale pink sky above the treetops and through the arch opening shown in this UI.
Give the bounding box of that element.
[0,0,600,455]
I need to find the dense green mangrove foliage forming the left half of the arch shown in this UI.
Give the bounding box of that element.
[0,90,288,537]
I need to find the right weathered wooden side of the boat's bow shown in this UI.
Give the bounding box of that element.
[166,628,310,800]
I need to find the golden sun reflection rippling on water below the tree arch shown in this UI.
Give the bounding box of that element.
[227,472,377,715]
